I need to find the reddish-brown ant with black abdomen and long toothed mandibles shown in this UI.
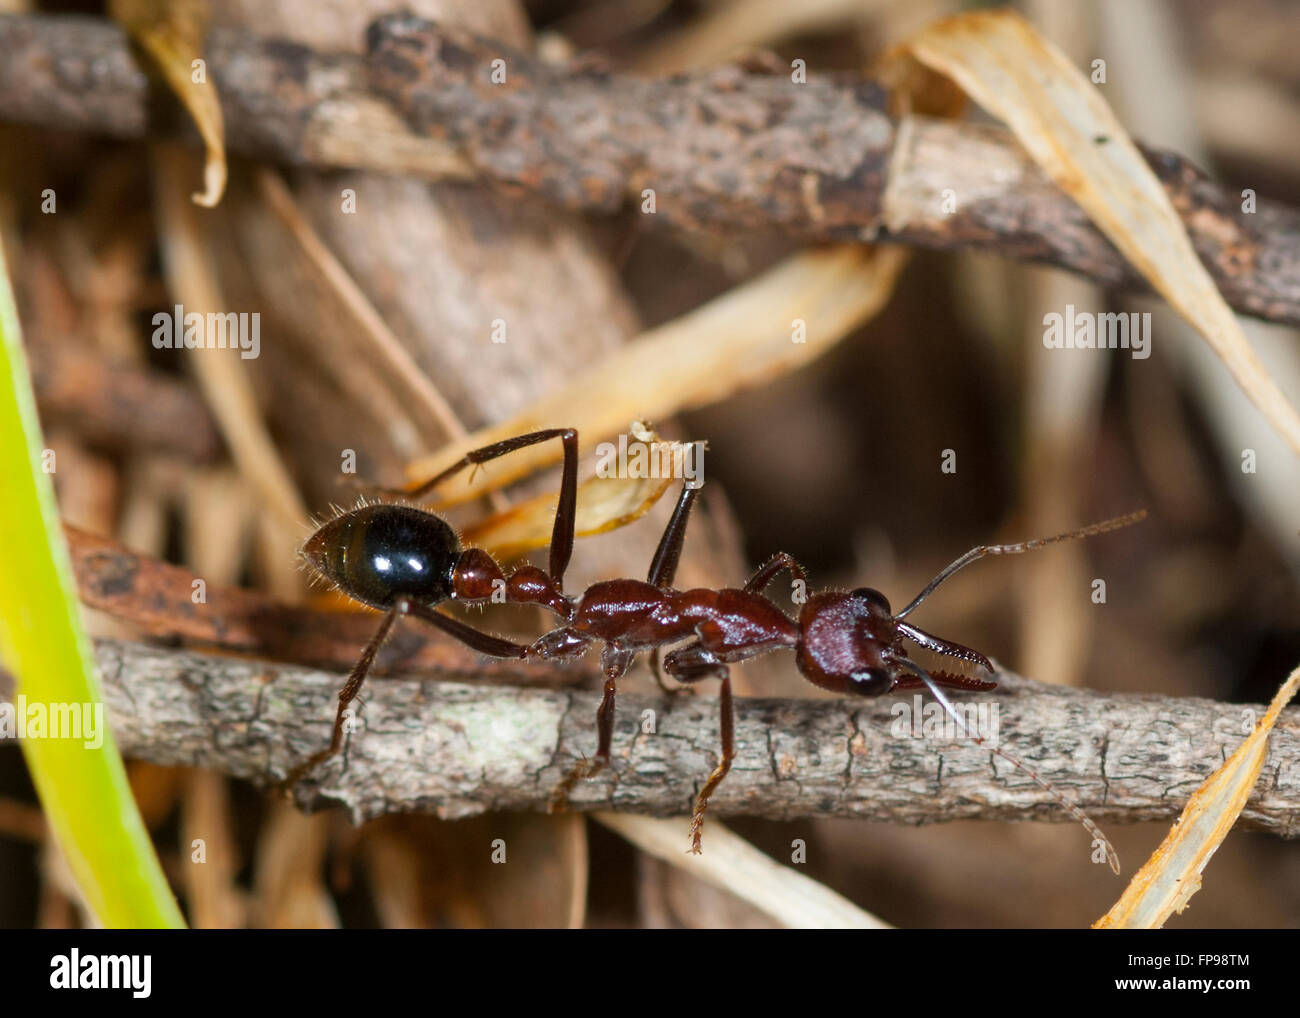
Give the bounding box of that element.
[286,428,1147,874]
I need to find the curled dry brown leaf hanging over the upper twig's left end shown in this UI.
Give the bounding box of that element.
[108,0,226,208]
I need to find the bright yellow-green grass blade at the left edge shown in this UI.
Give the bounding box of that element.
[0,243,185,928]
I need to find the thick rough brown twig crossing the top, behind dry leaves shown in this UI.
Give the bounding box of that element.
[0,16,1300,324]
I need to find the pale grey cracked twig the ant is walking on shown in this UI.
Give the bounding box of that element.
[73,640,1300,852]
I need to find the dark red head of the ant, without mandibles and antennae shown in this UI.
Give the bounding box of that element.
[796,588,902,697]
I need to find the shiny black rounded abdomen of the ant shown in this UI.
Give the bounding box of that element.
[302,504,460,608]
